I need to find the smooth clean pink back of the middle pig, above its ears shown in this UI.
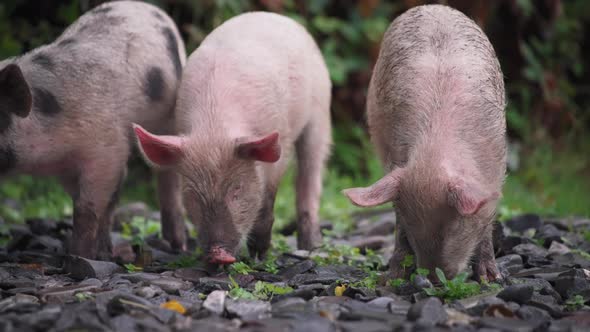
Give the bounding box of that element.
[176,12,331,144]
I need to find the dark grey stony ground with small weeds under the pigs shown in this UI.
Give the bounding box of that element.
[0,204,590,332]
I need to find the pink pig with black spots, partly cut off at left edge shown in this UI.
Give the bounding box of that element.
[0,1,186,258]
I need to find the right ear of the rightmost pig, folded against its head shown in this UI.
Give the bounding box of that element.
[447,179,500,217]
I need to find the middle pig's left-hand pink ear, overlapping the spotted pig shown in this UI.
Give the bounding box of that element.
[133,124,183,167]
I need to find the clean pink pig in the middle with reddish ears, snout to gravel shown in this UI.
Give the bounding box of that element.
[135,12,331,264]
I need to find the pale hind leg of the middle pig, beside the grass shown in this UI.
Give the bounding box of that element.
[295,117,331,250]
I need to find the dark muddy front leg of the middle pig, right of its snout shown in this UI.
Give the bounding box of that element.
[248,189,276,260]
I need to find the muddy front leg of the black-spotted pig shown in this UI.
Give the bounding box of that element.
[70,151,127,259]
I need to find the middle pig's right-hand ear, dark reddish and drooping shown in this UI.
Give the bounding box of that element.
[236,132,281,163]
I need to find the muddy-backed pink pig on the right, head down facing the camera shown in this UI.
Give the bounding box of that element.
[345,5,506,280]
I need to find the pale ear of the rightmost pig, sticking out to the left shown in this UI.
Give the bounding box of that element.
[342,168,403,207]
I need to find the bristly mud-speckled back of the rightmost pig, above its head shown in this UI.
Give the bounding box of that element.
[367,5,506,181]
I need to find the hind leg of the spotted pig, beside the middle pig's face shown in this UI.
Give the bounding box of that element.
[158,170,186,251]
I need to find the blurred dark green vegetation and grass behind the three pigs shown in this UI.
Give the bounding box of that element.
[0,0,590,228]
